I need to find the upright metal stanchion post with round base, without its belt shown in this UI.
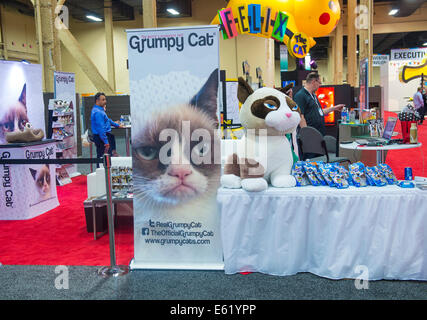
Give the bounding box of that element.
[98,154,129,277]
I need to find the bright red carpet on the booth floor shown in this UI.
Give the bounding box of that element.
[0,112,427,266]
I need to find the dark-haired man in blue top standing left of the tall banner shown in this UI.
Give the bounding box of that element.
[90,92,121,158]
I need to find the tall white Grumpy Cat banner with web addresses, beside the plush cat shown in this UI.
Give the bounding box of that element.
[127,26,223,269]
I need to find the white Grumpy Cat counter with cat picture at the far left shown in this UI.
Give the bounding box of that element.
[0,139,59,220]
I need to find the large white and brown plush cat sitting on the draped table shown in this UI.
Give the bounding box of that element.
[221,77,301,191]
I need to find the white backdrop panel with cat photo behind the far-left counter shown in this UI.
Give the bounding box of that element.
[0,61,45,144]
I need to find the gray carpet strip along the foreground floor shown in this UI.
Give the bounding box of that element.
[0,266,427,300]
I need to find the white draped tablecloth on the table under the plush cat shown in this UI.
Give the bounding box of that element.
[218,186,427,280]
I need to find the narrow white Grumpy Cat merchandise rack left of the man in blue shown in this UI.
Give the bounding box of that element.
[52,71,79,177]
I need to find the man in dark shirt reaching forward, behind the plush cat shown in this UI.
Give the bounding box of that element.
[293,72,345,136]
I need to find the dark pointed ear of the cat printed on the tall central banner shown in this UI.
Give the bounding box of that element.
[190,69,219,121]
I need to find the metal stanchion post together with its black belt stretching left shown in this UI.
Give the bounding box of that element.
[0,154,129,277]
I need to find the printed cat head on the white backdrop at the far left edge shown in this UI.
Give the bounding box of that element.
[0,84,28,144]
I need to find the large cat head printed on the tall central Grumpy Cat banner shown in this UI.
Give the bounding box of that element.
[132,69,220,213]
